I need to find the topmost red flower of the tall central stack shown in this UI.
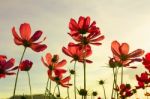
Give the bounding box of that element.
[69,16,100,36]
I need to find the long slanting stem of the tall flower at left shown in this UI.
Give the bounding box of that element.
[13,47,26,99]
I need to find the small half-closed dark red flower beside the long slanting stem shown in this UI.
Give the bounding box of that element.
[19,60,33,71]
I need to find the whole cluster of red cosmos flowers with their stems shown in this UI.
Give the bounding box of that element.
[0,16,150,99]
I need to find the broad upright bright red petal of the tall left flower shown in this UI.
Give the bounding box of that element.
[20,23,31,40]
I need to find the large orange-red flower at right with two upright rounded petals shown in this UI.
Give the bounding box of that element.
[111,41,144,67]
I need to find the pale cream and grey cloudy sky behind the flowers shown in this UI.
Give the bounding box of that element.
[0,0,150,98]
